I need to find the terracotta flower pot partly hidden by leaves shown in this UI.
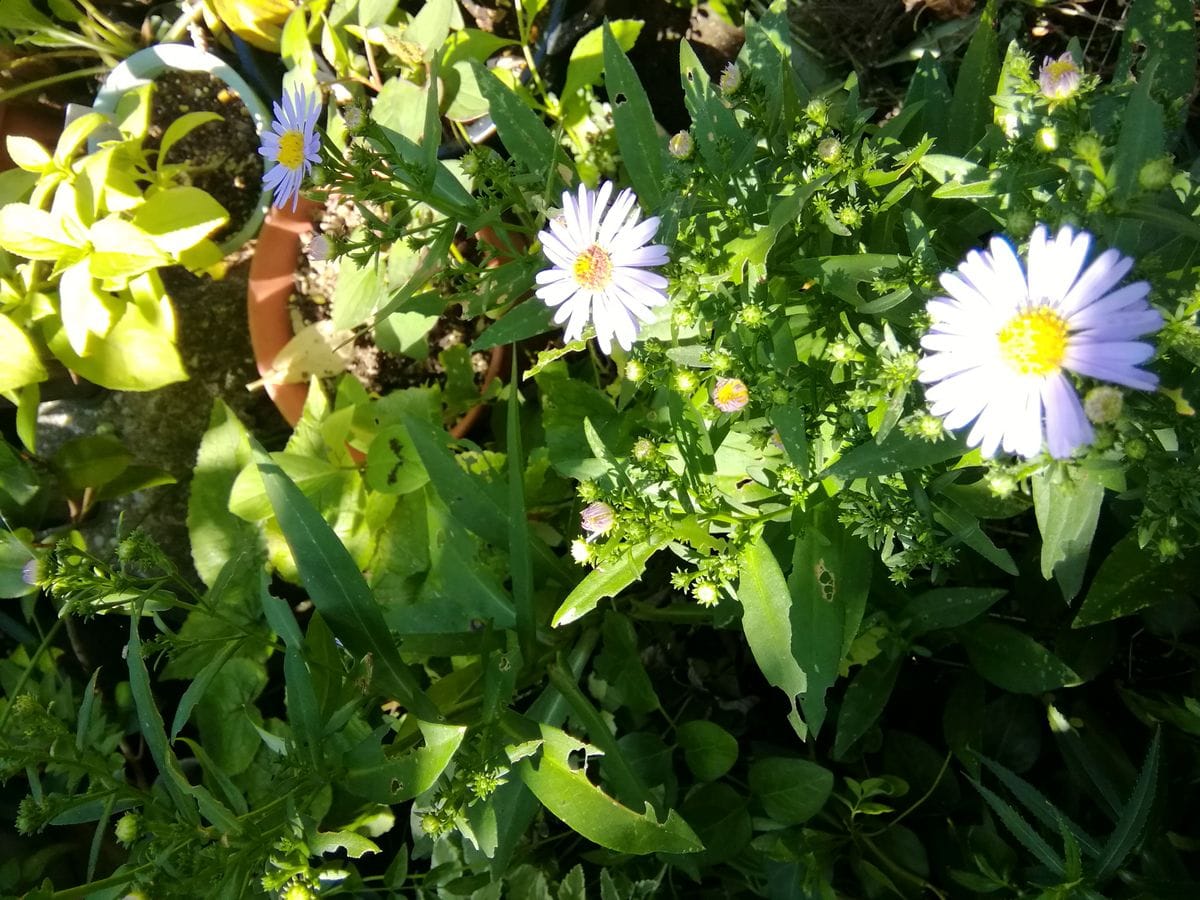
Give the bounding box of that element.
[246,198,509,438]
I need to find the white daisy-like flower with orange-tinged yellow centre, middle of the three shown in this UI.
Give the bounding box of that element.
[535,181,667,353]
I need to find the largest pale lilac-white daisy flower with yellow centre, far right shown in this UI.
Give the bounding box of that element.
[918,226,1163,458]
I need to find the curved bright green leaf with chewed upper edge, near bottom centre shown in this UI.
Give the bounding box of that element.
[515,724,703,854]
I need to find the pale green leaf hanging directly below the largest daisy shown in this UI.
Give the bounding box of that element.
[1032,468,1104,601]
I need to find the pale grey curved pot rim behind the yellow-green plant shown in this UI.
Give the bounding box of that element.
[88,43,271,254]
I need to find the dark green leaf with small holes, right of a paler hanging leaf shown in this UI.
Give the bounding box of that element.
[787,504,874,736]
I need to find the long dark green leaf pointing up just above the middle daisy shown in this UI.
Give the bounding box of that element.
[604,22,662,210]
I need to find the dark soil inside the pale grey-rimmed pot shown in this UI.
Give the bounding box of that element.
[145,71,263,244]
